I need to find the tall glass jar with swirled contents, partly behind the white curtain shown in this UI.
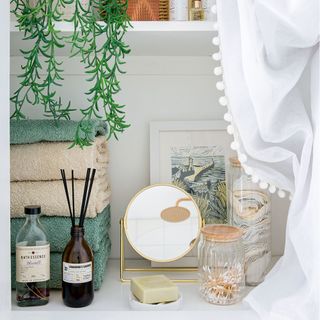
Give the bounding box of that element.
[227,158,271,285]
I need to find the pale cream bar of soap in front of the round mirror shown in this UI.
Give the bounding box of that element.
[131,275,179,303]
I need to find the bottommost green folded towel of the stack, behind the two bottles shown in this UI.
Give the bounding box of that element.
[11,237,111,290]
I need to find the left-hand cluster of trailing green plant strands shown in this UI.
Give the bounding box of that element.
[11,0,74,120]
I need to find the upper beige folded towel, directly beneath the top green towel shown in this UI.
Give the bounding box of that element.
[10,136,108,181]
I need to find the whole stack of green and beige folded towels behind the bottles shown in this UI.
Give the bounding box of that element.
[10,120,111,289]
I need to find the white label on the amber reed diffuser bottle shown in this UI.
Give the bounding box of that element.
[62,261,92,283]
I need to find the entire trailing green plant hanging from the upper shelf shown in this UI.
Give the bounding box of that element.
[11,0,130,148]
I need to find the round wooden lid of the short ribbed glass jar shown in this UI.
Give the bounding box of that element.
[201,224,243,242]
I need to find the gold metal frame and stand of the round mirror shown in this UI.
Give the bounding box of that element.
[120,184,204,282]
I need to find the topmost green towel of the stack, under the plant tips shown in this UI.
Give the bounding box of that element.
[10,120,108,144]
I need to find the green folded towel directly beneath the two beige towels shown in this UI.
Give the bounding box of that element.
[11,205,111,253]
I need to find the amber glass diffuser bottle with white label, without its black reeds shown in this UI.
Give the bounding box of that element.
[62,226,94,308]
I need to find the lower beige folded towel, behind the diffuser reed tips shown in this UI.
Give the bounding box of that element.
[10,176,111,218]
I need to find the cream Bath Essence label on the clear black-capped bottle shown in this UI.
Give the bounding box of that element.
[16,244,50,282]
